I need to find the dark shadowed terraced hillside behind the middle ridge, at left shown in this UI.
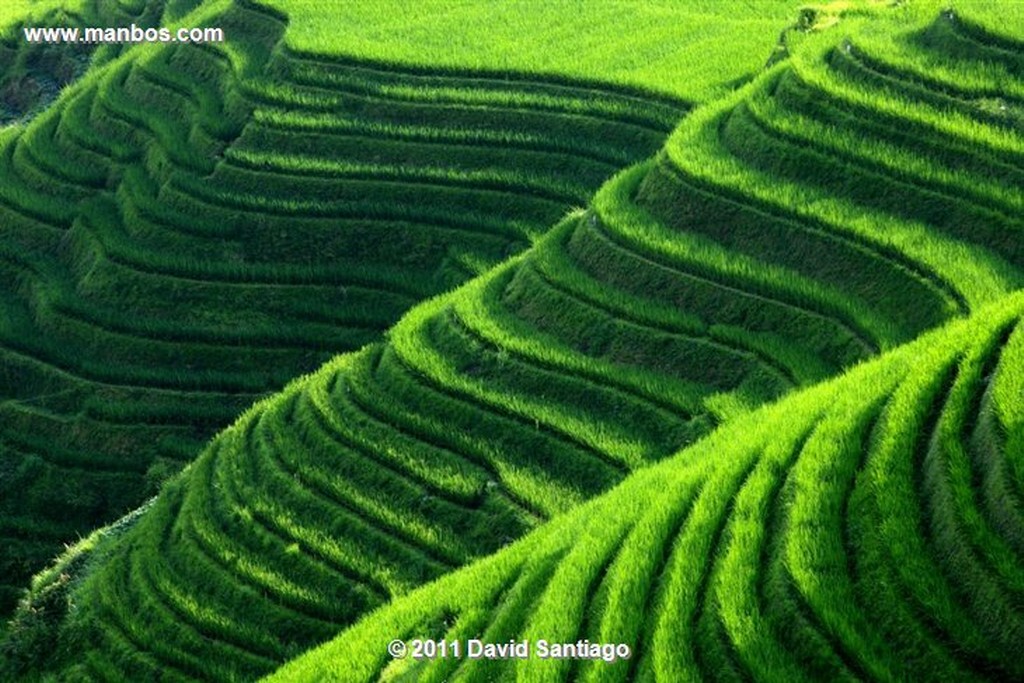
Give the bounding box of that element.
[0,2,684,613]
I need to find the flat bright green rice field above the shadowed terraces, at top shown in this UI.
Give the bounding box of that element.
[256,0,795,101]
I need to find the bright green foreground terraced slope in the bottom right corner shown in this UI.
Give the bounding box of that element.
[268,286,1024,682]
